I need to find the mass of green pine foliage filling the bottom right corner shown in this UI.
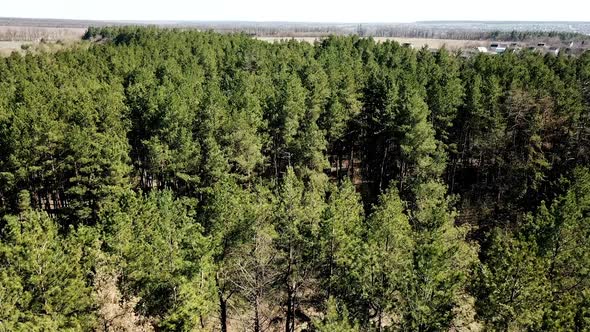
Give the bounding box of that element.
[476,168,590,331]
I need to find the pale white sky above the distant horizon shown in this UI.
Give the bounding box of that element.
[0,0,590,22]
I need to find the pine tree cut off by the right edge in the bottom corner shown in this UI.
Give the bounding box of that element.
[531,168,590,331]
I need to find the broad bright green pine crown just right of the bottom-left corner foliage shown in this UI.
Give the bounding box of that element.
[104,192,215,331]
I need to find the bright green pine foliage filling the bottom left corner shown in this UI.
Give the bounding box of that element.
[0,192,97,331]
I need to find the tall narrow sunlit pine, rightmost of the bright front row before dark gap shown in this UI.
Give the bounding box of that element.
[403,182,476,331]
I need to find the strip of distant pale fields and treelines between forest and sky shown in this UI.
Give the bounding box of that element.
[0,17,590,56]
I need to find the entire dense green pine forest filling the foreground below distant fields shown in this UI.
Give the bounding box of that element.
[0,27,590,332]
